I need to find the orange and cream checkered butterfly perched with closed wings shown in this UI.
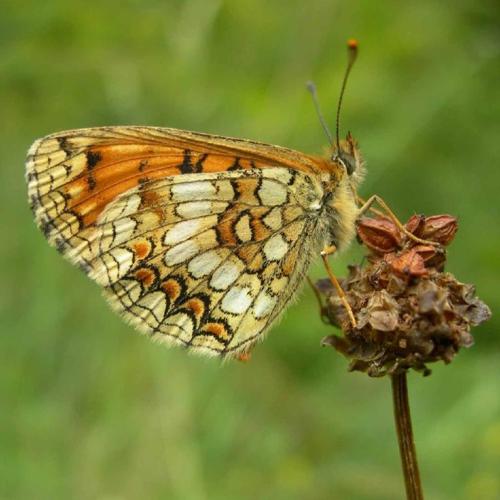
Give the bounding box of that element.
[26,43,363,357]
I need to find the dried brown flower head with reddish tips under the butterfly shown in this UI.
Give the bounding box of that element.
[318,215,491,377]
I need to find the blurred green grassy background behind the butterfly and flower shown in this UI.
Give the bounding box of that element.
[0,0,500,500]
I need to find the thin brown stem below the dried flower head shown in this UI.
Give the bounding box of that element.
[391,373,424,500]
